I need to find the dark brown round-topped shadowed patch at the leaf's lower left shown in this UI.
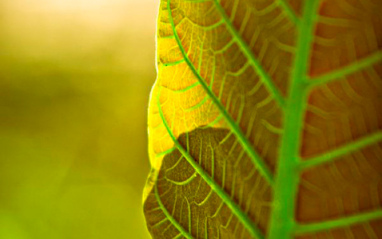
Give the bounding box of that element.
[144,128,272,238]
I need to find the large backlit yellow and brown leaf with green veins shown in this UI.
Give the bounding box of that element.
[144,0,382,239]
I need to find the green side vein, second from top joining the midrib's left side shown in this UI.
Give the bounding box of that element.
[214,0,285,107]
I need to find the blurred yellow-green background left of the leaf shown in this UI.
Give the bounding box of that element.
[0,0,159,239]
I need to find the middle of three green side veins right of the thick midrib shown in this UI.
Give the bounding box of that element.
[298,131,382,170]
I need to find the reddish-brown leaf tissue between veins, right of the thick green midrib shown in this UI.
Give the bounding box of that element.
[297,0,382,230]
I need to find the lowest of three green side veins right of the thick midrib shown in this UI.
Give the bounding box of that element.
[295,209,382,234]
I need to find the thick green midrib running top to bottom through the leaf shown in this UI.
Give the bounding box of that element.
[269,0,318,239]
